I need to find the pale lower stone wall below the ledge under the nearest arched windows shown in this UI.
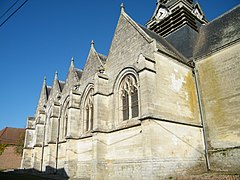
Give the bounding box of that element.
[59,120,205,180]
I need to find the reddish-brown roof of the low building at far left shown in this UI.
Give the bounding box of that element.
[0,127,25,145]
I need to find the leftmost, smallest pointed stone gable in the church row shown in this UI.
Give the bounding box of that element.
[36,77,51,113]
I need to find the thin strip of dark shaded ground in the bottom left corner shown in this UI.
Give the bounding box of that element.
[0,172,50,180]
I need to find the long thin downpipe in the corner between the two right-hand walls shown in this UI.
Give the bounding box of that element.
[193,60,211,171]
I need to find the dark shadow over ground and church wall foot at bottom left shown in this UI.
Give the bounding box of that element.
[0,166,69,180]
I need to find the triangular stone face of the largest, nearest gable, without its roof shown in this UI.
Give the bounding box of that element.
[106,9,154,77]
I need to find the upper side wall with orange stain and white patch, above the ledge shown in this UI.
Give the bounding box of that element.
[154,53,201,125]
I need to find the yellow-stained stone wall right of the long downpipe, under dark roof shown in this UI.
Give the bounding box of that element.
[196,44,240,171]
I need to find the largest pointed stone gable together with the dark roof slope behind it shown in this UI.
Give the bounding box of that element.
[106,6,187,76]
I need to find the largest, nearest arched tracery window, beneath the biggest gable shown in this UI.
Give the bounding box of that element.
[120,75,139,120]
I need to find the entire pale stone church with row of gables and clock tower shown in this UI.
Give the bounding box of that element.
[21,0,240,179]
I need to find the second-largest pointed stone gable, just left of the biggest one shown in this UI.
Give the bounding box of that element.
[81,42,106,82]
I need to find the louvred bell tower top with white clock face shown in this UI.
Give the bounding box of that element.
[146,0,207,37]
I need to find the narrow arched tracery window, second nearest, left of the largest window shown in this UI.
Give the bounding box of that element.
[84,88,94,131]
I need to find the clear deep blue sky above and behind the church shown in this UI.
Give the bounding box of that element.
[0,0,240,129]
